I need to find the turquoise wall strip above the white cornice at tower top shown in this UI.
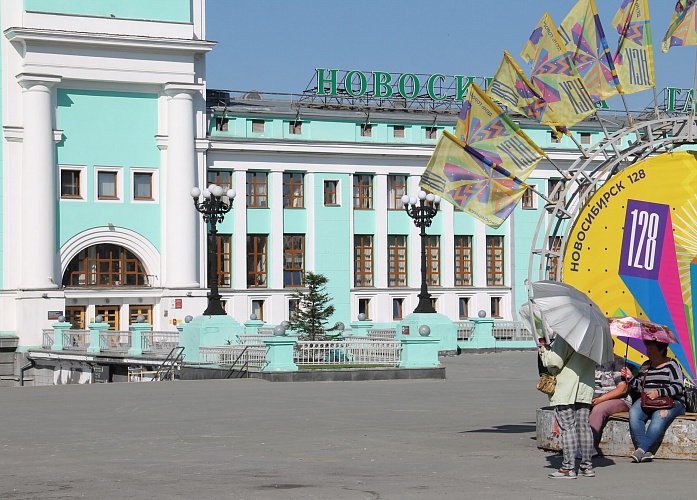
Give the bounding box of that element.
[24,0,192,23]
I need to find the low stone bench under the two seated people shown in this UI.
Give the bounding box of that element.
[537,406,697,460]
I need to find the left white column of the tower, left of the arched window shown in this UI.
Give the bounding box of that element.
[17,73,61,290]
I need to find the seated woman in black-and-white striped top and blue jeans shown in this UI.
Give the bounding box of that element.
[622,340,685,462]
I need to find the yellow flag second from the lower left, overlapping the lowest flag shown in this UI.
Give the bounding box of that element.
[455,83,545,180]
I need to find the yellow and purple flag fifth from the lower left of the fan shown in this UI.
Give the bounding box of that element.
[559,0,621,103]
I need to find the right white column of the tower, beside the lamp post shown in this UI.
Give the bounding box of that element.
[162,83,204,288]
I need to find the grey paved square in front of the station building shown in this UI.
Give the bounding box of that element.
[0,352,697,500]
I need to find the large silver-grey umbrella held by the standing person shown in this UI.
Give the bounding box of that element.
[520,281,614,364]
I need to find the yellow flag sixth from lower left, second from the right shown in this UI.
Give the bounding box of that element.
[612,0,656,94]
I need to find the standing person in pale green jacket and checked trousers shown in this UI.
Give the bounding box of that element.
[540,335,595,479]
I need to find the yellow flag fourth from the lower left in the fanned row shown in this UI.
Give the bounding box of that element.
[521,12,595,127]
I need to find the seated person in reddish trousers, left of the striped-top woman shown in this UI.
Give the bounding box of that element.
[588,355,632,450]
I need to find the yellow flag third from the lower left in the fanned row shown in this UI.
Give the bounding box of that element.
[486,50,561,125]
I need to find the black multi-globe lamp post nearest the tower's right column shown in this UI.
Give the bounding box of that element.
[191,184,236,316]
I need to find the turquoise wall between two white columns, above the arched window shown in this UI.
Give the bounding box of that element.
[56,89,160,250]
